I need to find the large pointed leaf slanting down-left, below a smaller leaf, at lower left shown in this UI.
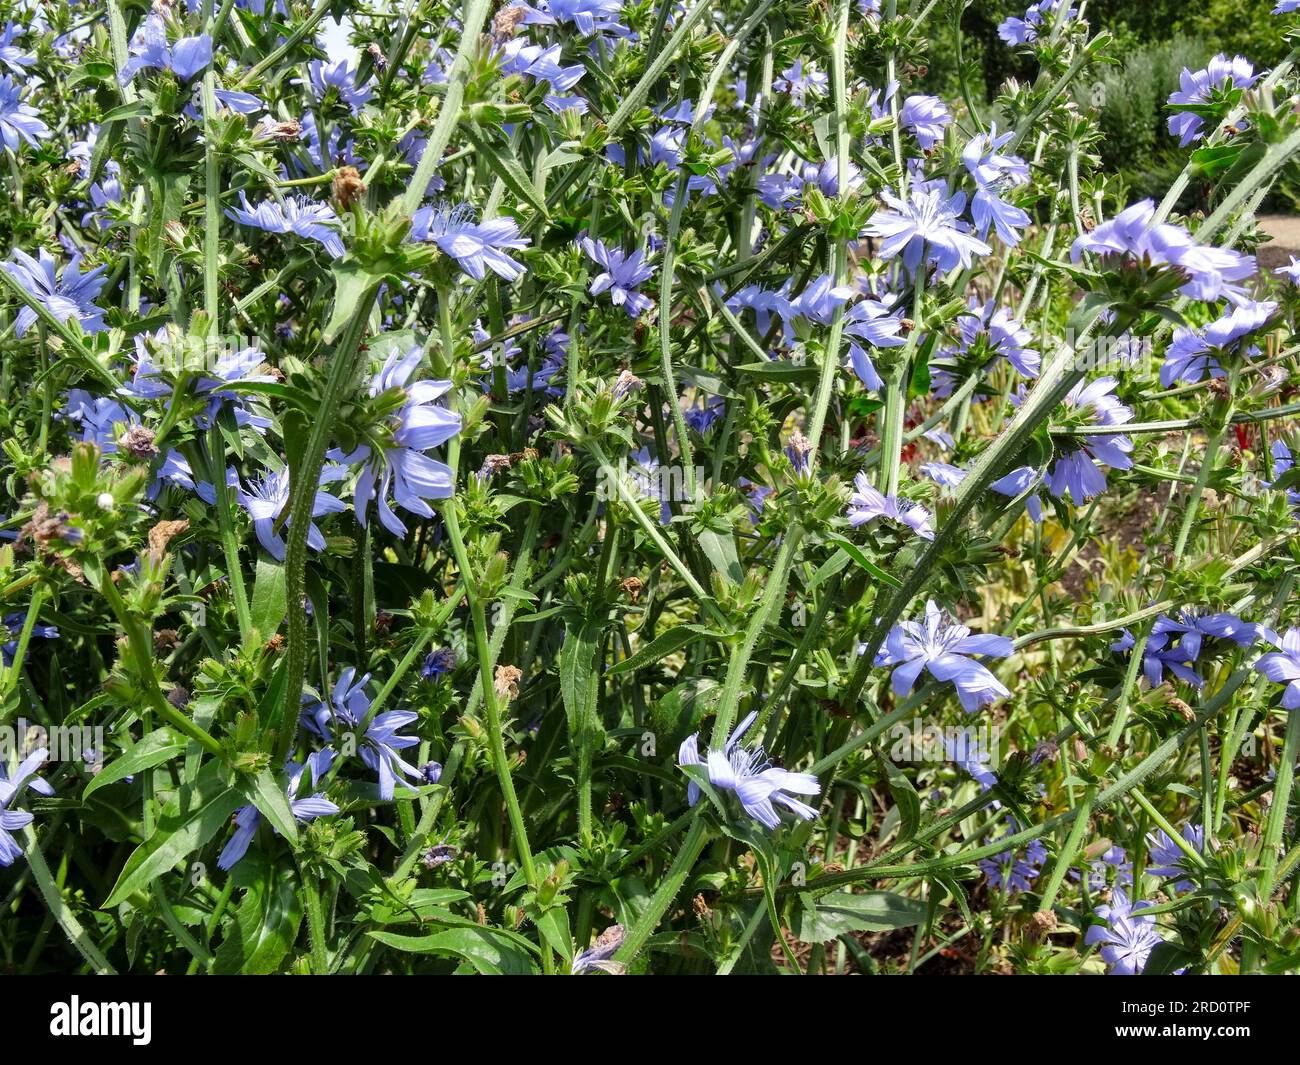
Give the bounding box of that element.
[104,761,246,909]
